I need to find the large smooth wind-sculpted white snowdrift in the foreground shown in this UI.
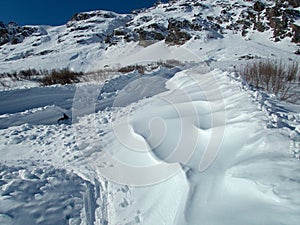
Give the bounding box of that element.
[71,67,300,224]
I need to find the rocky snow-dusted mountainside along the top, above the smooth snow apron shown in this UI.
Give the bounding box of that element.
[0,0,300,72]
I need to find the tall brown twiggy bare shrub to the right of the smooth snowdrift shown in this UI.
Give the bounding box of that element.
[241,60,299,100]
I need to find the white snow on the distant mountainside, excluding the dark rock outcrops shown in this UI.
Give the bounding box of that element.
[0,1,297,77]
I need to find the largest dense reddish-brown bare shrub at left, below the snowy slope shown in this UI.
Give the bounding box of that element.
[39,69,83,86]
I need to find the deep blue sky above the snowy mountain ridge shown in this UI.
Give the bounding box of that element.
[0,0,167,25]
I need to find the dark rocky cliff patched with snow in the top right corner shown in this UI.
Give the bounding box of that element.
[191,0,300,43]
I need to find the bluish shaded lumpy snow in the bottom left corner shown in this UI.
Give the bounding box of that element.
[0,161,87,224]
